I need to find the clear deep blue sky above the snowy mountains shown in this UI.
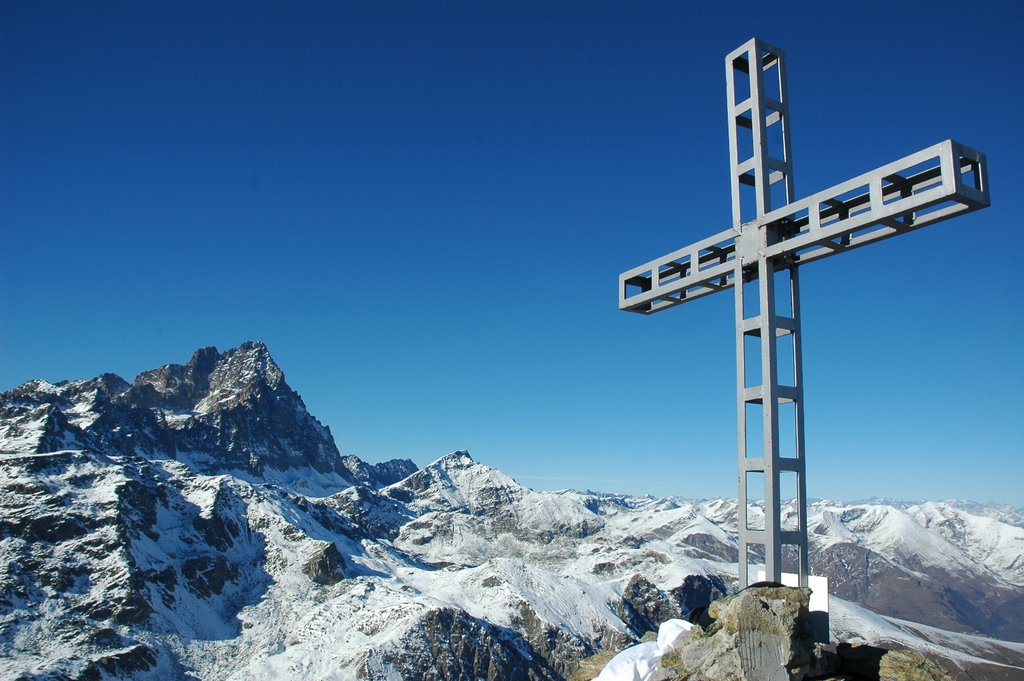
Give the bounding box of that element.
[0,1,1024,505]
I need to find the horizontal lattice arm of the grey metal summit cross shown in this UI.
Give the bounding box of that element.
[618,139,989,314]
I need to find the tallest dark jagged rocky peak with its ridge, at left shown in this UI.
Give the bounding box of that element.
[0,342,416,492]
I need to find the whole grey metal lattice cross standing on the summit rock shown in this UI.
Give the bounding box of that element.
[618,38,989,587]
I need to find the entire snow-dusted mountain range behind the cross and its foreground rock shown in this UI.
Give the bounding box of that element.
[0,343,1024,681]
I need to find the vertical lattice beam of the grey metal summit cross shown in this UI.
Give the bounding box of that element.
[725,38,809,588]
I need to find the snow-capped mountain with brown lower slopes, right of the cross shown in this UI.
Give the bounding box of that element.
[808,502,1024,641]
